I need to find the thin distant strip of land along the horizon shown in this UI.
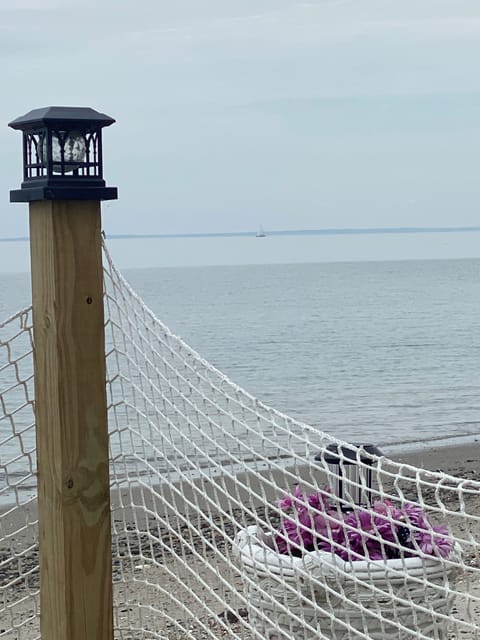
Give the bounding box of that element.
[0,226,480,242]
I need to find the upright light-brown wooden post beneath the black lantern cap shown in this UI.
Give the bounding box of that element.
[30,200,113,640]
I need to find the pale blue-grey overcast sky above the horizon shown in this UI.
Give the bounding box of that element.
[0,0,480,264]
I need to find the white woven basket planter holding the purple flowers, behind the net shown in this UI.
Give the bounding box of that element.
[233,525,459,640]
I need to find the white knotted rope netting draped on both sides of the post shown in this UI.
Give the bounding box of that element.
[0,242,480,640]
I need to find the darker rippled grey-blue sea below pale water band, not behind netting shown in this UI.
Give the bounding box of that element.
[0,252,480,458]
